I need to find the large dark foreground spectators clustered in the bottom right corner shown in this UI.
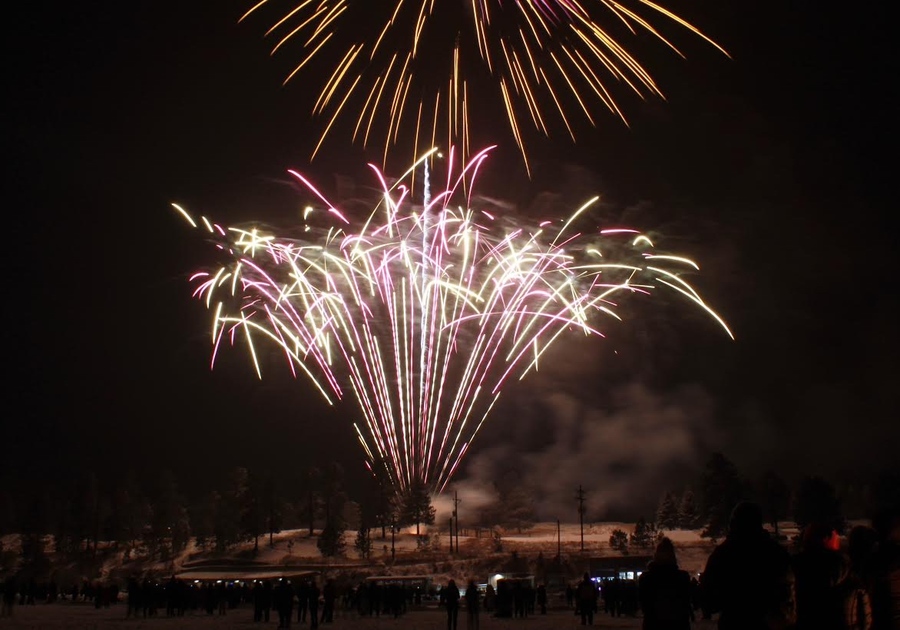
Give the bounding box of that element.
[566,502,900,630]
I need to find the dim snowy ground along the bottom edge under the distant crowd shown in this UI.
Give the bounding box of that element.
[0,603,715,630]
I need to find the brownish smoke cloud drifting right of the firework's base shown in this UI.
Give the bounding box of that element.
[456,334,720,522]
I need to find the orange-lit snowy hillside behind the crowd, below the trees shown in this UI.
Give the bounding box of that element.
[2,522,732,589]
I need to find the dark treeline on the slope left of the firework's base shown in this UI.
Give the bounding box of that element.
[0,464,435,574]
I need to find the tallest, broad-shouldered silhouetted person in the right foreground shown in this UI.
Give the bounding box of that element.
[700,501,795,630]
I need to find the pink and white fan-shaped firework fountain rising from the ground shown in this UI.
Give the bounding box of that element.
[175,150,731,492]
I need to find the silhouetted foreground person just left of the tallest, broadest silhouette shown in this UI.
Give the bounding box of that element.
[638,538,694,630]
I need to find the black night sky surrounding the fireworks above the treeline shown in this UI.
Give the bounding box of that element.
[0,0,900,503]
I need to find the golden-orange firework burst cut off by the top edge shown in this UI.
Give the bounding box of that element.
[240,0,727,173]
